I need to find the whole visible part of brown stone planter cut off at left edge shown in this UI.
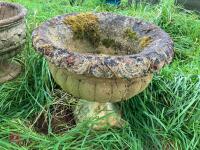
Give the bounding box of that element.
[0,2,26,83]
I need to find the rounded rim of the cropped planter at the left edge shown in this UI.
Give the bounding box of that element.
[0,2,27,27]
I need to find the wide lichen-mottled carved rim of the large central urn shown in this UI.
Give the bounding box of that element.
[32,13,174,79]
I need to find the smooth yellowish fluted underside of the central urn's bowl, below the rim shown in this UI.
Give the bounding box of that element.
[49,63,152,103]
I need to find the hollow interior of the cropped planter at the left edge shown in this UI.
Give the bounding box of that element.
[0,3,19,20]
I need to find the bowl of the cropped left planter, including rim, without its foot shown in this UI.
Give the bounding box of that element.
[0,2,26,60]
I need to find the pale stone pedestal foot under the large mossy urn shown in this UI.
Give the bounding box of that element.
[74,100,125,130]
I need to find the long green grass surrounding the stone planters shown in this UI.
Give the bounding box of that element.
[0,0,200,150]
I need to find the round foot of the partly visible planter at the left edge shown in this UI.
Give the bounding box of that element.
[0,60,21,83]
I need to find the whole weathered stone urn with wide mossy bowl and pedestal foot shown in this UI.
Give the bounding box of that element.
[33,13,173,129]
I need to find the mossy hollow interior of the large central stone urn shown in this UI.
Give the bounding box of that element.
[45,13,152,55]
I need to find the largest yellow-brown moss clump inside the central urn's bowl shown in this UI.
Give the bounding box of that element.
[63,13,100,47]
